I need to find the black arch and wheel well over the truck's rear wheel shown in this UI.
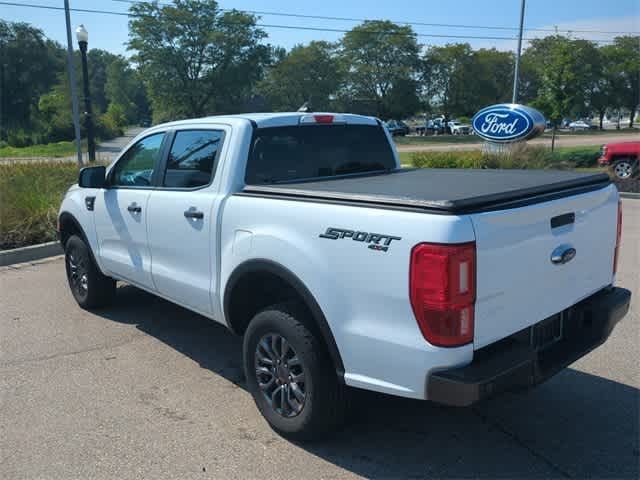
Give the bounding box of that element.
[223,259,344,382]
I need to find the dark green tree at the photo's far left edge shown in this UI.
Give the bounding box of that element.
[0,20,64,139]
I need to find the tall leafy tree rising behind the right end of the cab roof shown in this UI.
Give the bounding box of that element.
[340,20,419,118]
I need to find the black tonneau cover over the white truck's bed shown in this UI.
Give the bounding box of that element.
[242,168,610,214]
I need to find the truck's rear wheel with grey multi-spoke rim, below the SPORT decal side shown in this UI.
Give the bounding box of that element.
[243,304,348,440]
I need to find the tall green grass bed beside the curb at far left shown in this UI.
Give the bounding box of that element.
[0,162,78,249]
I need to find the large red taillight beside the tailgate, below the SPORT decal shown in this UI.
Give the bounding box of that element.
[409,242,476,347]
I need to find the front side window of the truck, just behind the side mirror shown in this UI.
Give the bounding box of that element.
[111,133,164,187]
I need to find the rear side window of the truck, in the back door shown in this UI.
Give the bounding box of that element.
[163,130,224,188]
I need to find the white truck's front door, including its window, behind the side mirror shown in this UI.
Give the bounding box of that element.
[94,132,165,288]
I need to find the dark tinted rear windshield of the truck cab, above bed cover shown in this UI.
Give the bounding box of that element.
[245,125,396,184]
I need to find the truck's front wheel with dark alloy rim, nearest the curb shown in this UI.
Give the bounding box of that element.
[64,235,116,309]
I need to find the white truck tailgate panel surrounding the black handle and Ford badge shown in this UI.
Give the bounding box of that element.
[471,186,617,349]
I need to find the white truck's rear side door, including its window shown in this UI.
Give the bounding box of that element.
[148,127,226,314]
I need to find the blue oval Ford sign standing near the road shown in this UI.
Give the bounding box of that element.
[471,103,546,143]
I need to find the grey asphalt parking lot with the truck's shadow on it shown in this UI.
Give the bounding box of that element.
[0,200,640,479]
